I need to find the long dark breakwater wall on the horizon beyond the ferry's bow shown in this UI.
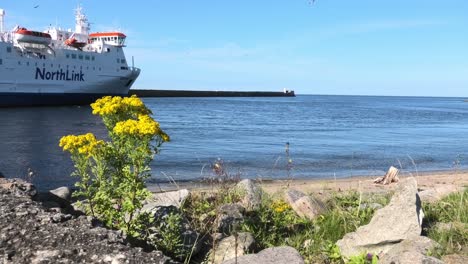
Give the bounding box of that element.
[128,89,296,97]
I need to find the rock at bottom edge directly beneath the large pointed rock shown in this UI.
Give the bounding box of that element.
[379,236,442,264]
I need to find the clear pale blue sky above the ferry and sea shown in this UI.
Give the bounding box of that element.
[0,0,468,97]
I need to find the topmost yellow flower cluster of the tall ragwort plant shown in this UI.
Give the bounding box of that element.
[91,95,147,116]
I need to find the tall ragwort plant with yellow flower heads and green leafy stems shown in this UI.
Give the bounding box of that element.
[59,96,169,235]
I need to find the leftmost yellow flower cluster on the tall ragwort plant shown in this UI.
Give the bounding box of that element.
[59,133,104,156]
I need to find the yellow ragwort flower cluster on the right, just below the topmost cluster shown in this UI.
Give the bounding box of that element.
[113,115,169,141]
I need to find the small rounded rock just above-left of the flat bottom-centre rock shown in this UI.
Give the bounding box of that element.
[208,233,255,264]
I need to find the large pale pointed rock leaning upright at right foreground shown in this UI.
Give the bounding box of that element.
[336,177,424,257]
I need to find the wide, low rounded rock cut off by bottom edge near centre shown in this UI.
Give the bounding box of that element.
[223,246,304,264]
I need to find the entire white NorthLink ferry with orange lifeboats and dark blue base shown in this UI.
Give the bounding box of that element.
[0,7,140,106]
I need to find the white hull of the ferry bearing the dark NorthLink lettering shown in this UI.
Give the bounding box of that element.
[0,6,140,106]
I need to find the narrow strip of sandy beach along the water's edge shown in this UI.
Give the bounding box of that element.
[147,170,468,193]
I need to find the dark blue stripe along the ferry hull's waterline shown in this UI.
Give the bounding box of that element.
[0,93,127,107]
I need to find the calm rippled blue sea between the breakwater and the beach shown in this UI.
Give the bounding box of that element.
[0,95,468,189]
